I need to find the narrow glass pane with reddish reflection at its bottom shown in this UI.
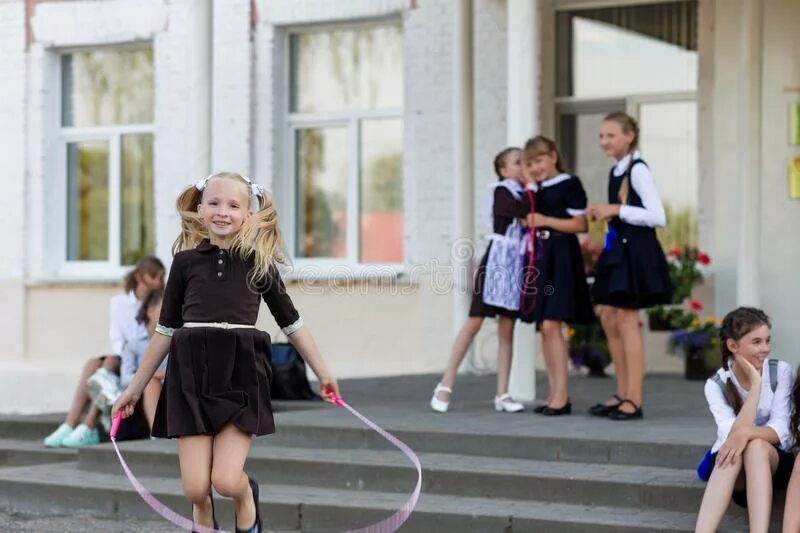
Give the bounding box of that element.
[360,119,403,263]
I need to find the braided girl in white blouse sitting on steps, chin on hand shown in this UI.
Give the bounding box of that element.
[695,307,796,533]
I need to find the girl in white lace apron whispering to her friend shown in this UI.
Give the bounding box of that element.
[430,147,532,413]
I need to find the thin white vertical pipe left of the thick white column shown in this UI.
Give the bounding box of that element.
[451,0,475,332]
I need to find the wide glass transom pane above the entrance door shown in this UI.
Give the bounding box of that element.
[556,1,697,97]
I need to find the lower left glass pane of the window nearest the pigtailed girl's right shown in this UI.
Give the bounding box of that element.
[295,128,347,258]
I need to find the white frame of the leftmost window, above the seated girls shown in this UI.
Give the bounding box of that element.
[55,43,155,280]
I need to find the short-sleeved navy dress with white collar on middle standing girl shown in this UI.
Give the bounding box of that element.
[520,174,595,324]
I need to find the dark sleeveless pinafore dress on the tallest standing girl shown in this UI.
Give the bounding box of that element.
[592,159,672,309]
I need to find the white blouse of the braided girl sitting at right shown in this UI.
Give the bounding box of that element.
[705,361,792,453]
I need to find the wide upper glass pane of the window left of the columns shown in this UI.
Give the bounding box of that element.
[290,25,403,113]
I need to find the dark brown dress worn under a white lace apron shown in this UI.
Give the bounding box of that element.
[469,186,531,318]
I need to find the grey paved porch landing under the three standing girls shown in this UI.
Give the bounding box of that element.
[270,368,714,446]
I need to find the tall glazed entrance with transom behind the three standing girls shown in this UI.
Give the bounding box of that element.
[556,0,698,249]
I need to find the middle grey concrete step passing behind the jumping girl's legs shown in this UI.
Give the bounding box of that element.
[79,441,705,512]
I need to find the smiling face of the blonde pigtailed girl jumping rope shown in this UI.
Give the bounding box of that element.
[197,177,250,245]
